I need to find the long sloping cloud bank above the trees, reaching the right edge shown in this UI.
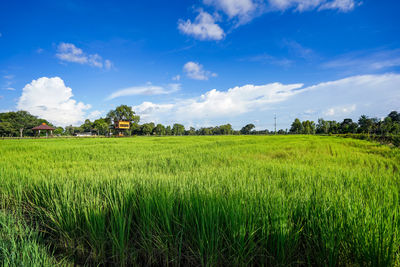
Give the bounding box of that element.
[133,73,400,129]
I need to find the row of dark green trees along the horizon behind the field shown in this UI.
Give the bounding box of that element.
[0,105,400,137]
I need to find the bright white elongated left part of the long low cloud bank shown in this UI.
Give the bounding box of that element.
[133,83,302,121]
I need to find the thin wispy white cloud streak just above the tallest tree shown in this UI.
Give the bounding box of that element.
[107,83,181,100]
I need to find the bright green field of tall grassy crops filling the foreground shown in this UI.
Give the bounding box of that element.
[0,136,400,266]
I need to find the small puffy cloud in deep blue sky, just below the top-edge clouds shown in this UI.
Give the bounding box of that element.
[178,10,225,40]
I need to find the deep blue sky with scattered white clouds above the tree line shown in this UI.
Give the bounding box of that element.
[0,0,400,130]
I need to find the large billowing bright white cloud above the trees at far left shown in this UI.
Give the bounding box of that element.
[17,77,91,126]
